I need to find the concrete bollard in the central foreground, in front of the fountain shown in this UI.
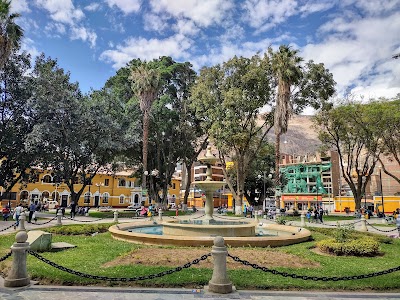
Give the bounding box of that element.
[208,236,233,294]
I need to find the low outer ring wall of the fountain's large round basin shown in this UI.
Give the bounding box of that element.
[109,221,311,247]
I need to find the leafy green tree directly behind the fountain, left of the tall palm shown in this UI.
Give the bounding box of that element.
[192,55,272,214]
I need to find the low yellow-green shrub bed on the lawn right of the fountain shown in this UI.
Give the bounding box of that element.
[317,237,380,256]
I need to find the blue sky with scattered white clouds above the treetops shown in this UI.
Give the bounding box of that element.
[11,0,400,107]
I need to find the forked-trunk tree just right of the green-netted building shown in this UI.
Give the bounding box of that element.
[314,102,381,209]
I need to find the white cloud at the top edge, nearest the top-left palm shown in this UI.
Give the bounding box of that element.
[35,0,85,25]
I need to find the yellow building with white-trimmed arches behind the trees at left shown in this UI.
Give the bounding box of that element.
[1,171,180,208]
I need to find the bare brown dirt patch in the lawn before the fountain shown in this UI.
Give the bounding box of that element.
[103,248,319,269]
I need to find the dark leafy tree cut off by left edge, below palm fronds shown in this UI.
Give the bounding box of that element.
[0,51,35,192]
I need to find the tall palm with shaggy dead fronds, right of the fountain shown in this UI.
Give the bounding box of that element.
[272,45,303,208]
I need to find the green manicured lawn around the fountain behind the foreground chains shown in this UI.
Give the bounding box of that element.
[0,225,400,291]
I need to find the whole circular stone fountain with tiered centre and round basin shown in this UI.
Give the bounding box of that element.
[109,147,311,247]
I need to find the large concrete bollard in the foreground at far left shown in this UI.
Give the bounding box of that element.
[4,231,30,287]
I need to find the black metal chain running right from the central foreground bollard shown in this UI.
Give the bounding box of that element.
[228,253,400,281]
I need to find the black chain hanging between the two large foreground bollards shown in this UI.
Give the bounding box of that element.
[28,250,211,282]
